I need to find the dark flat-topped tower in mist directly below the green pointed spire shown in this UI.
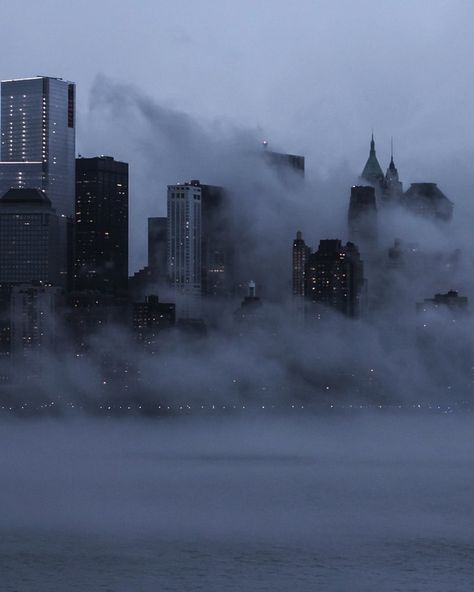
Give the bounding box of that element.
[348,185,377,250]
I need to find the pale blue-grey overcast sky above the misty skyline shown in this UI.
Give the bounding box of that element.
[0,0,474,268]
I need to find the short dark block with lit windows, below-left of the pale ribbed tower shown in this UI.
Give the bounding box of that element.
[132,295,176,353]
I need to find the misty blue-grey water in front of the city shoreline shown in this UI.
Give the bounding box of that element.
[0,416,474,592]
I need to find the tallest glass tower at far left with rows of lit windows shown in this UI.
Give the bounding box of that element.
[0,76,76,216]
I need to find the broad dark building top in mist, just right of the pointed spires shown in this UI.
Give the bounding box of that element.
[401,183,454,222]
